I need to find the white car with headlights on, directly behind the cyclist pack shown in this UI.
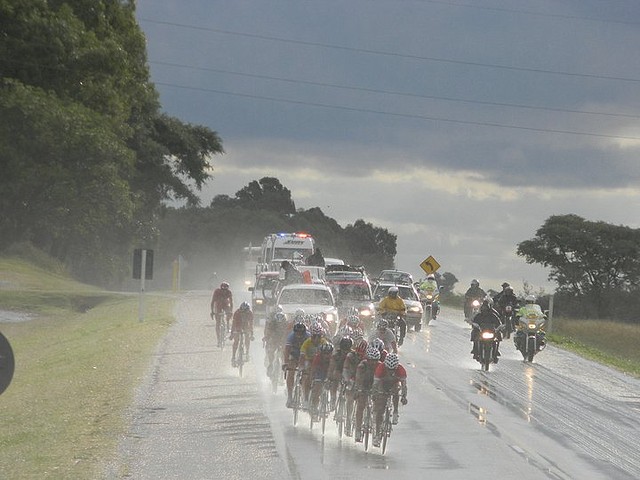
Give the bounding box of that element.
[276,283,338,332]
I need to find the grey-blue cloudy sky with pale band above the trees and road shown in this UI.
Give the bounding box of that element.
[137,0,640,291]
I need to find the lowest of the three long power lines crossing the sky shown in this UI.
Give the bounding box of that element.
[154,82,640,140]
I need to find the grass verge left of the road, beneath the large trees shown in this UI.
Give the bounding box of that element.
[0,290,174,480]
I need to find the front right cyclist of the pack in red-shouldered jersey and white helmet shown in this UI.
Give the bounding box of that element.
[372,353,407,447]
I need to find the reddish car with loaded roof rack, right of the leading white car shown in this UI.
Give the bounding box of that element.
[326,265,375,330]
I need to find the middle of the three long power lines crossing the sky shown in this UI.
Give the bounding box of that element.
[149,61,640,118]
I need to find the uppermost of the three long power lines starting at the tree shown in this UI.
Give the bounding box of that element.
[139,18,640,83]
